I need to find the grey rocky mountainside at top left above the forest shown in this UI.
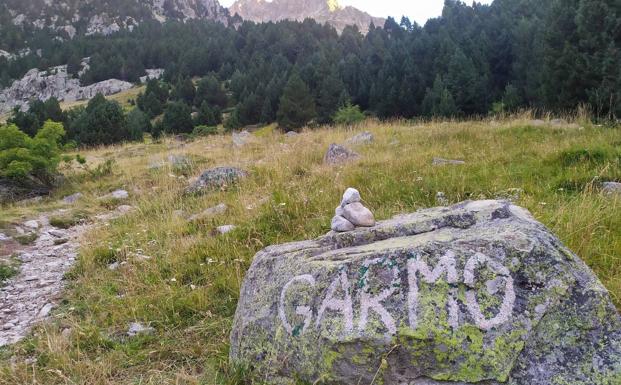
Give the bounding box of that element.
[0,0,228,38]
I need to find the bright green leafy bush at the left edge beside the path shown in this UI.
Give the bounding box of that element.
[0,121,65,185]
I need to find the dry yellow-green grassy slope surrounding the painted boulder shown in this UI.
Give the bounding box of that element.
[0,120,621,384]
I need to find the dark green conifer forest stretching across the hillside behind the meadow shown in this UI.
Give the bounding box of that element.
[0,0,621,125]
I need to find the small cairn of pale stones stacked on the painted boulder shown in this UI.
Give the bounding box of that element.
[331,188,375,233]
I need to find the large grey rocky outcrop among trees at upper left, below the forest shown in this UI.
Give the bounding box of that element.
[0,66,133,114]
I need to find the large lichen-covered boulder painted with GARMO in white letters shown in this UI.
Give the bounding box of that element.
[230,201,621,385]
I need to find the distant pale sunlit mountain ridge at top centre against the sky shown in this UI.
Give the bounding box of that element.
[229,0,385,33]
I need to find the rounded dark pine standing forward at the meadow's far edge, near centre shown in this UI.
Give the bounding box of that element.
[277,71,316,130]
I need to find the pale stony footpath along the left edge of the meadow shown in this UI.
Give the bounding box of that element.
[0,215,89,346]
